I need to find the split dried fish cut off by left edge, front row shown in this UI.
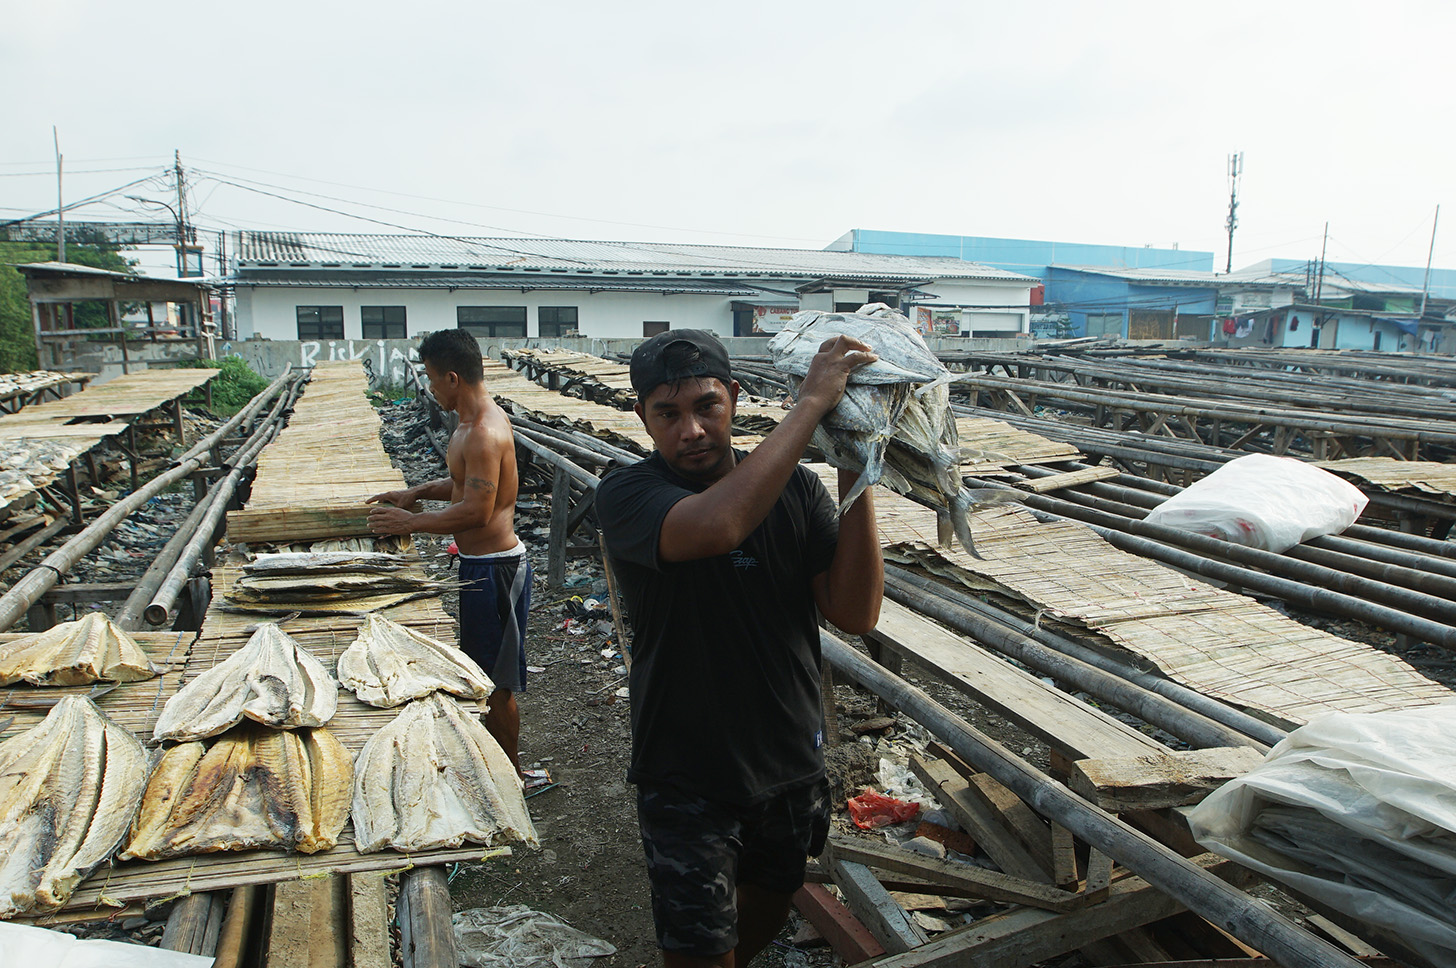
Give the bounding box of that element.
[0,696,147,917]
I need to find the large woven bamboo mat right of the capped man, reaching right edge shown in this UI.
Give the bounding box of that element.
[850,471,1453,725]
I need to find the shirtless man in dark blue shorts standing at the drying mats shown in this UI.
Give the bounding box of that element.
[368,329,531,771]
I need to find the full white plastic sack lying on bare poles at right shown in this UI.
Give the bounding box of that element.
[1146,454,1370,552]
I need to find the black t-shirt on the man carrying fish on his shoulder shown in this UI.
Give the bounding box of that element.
[597,453,839,804]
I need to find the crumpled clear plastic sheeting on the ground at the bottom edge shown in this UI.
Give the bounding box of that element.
[451,904,617,968]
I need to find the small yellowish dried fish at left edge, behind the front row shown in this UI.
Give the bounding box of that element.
[0,611,157,686]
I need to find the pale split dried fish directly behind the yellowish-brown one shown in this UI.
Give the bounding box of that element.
[153,622,339,741]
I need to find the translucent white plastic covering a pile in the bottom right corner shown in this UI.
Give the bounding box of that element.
[1188,702,1456,968]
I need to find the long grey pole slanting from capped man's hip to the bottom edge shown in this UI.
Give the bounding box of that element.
[820,632,1360,968]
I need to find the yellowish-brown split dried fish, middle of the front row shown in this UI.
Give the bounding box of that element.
[119,723,354,860]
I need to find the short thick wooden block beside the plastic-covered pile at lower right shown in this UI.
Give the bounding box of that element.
[1067,747,1264,814]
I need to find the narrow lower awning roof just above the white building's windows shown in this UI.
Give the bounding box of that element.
[237,269,757,294]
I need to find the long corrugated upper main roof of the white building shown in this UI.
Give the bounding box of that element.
[237,231,1037,285]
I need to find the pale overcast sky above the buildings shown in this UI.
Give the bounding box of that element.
[0,0,1456,279]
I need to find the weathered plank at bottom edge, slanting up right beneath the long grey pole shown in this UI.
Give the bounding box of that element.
[866,854,1235,968]
